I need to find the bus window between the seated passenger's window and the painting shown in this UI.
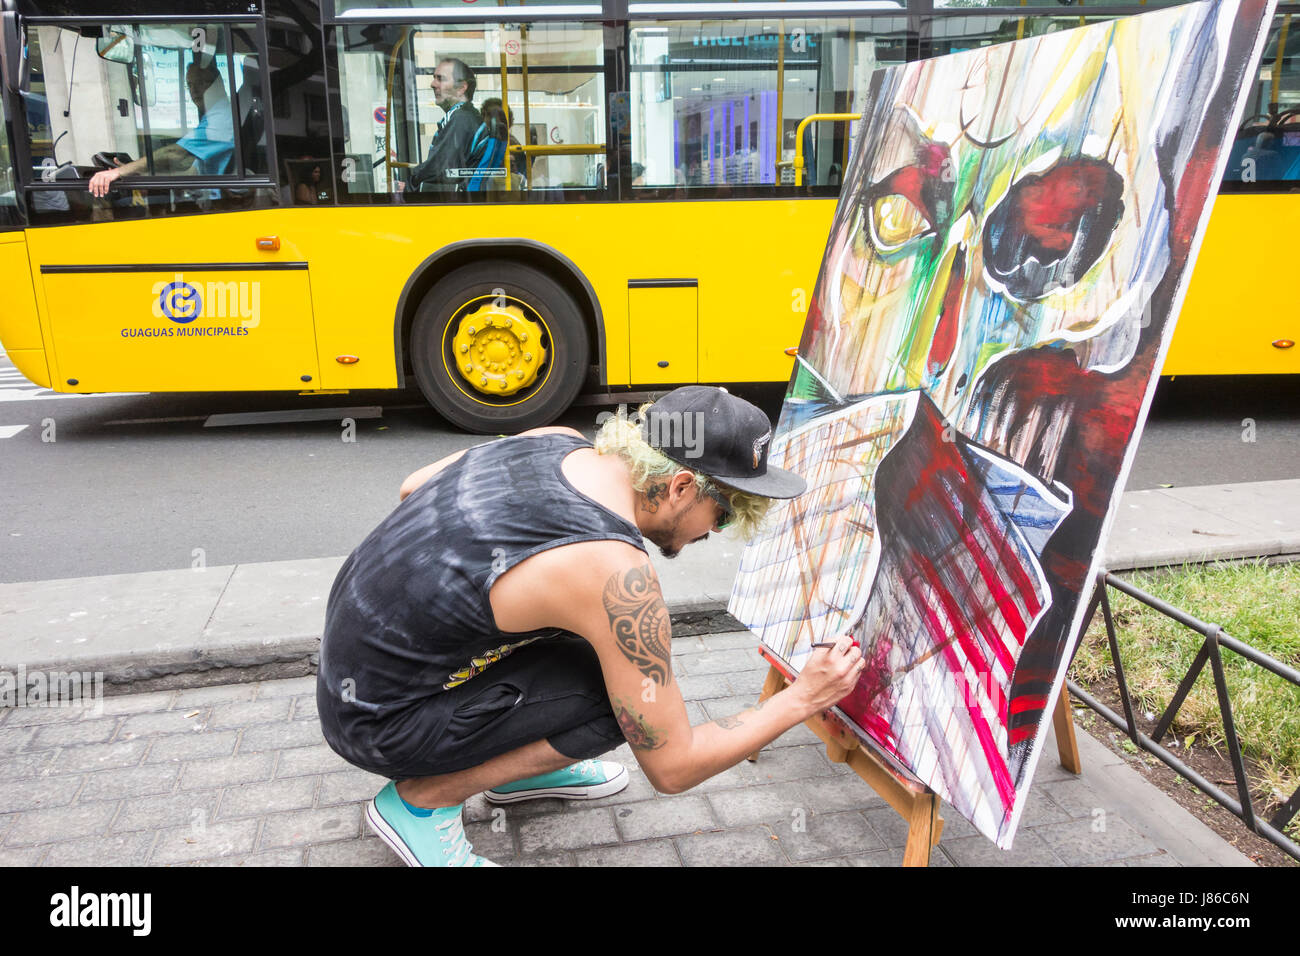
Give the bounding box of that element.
[629,17,907,195]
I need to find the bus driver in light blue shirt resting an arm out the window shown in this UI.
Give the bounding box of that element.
[90,56,235,196]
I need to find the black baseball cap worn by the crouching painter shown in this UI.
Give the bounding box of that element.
[641,385,807,498]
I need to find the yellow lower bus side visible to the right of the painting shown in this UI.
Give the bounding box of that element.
[1161,194,1300,375]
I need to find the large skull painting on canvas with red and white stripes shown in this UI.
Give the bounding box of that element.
[731,0,1273,847]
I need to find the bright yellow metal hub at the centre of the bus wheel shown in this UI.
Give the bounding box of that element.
[451,299,546,395]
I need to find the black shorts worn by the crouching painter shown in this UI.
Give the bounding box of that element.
[314,635,623,780]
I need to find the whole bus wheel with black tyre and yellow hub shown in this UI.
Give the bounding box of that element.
[411,260,589,434]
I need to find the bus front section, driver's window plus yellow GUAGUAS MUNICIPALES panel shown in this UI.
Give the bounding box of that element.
[20,11,320,392]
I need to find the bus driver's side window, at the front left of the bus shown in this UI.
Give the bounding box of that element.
[25,23,268,222]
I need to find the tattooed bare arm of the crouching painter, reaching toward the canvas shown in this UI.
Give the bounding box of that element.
[579,548,866,793]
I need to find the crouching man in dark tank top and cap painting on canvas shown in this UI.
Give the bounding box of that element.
[317,386,863,866]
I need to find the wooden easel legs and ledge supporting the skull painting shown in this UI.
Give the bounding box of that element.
[749,645,1083,866]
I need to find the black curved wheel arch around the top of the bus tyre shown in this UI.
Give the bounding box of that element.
[393,239,608,398]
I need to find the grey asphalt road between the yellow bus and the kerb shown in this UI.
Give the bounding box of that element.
[0,358,1300,583]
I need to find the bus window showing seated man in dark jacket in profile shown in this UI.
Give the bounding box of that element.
[339,22,606,202]
